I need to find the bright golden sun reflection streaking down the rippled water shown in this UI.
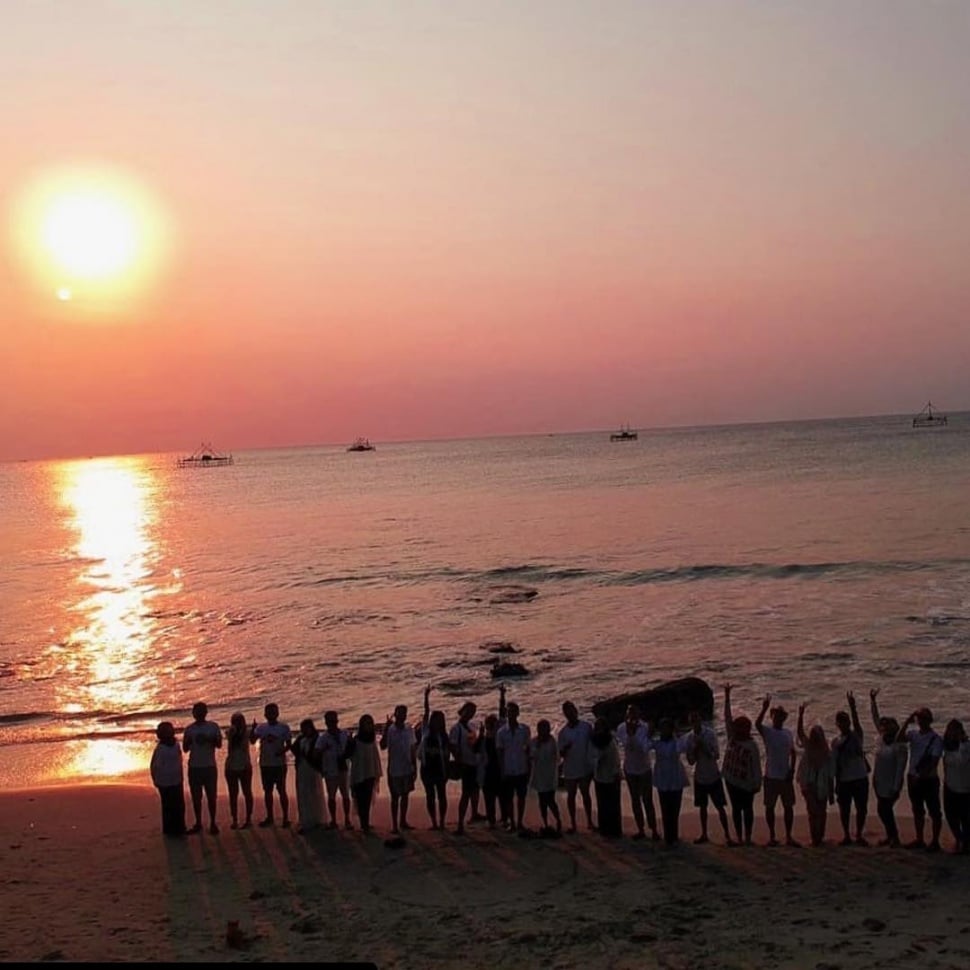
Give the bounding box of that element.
[49,457,169,778]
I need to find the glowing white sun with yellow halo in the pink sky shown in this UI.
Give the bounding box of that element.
[13,165,169,309]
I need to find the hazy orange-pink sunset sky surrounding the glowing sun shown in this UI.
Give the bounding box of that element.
[0,0,970,459]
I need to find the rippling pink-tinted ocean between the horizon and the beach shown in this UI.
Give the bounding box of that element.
[0,414,970,788]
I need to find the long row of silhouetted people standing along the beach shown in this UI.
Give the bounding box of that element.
[152,684,970,852]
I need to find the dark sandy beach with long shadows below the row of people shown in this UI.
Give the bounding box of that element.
[0,785,970,970]
